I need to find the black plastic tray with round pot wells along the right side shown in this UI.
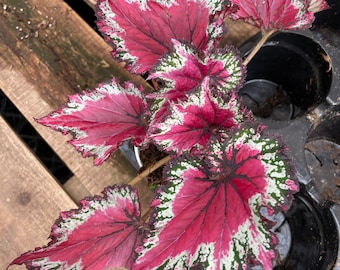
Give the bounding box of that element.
[239,4,340,270]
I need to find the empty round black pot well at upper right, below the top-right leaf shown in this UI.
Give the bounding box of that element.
[240,33,332,123]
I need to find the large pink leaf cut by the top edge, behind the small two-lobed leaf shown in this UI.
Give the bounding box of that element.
[97,0,230,73]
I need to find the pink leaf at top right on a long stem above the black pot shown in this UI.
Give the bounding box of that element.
[230,0,328,30]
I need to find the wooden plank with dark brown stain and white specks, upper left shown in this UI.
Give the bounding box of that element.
[0,0,153,202]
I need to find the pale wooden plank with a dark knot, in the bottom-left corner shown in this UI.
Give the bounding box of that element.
[0,117,76,269]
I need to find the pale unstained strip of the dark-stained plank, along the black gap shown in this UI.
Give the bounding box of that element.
[0,61,134,194]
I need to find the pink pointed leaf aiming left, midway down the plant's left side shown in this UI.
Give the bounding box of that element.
[37,79,147,165]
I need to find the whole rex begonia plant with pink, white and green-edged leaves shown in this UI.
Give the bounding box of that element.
[11,0,327,269]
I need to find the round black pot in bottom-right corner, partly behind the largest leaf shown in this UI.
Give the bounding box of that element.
[274,191,339,270]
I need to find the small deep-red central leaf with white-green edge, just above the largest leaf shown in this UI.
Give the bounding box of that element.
[151,78,245,154]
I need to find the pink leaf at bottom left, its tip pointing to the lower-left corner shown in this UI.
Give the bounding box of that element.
[11,186,142,270]
